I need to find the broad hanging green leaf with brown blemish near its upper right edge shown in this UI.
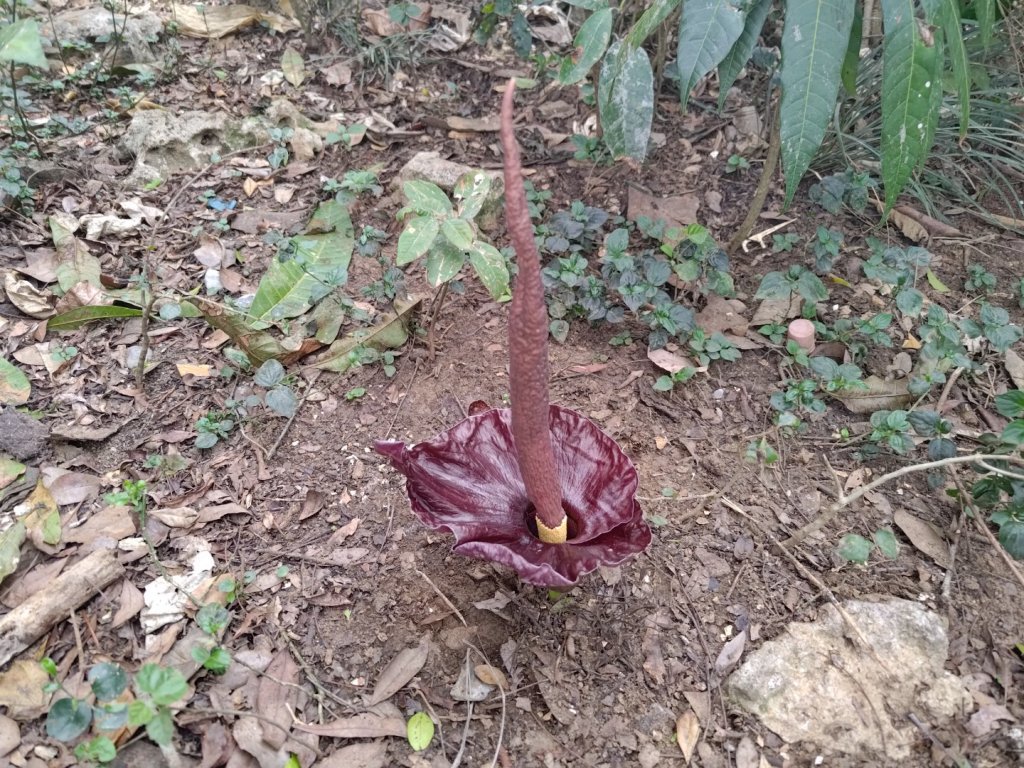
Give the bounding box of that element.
[880,0,942,215]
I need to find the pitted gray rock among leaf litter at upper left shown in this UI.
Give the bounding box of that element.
[120,110,268,184]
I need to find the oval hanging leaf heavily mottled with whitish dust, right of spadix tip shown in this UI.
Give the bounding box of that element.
[597,41,654,160]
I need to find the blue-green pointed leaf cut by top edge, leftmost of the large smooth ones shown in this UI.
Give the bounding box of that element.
[676,0,746,108]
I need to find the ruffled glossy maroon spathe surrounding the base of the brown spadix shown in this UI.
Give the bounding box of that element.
[376,406,651,588]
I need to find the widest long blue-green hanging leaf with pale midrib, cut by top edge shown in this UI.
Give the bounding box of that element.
[779,0,855,205]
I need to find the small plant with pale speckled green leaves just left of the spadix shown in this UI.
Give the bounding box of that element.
[395,171,509,301]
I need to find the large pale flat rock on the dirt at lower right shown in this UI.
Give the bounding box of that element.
[726,600,971,761]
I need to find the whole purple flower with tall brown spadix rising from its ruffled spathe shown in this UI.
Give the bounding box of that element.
[376,82,650,588]
